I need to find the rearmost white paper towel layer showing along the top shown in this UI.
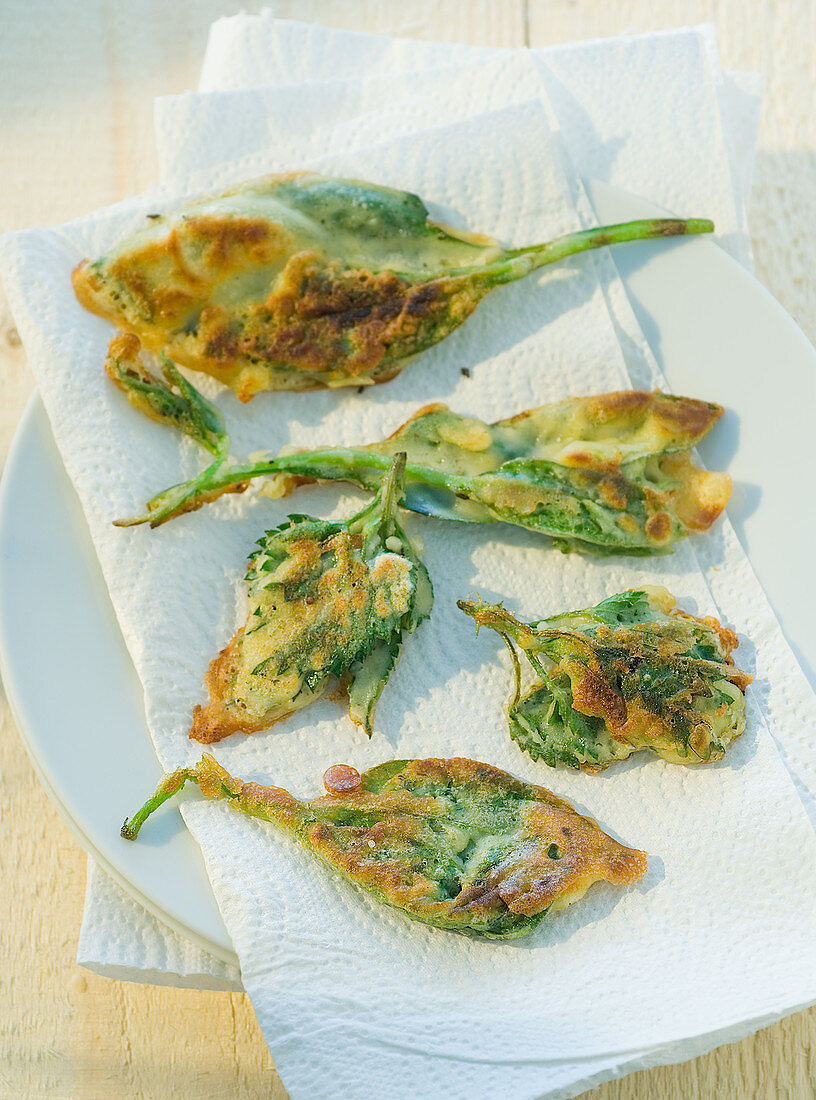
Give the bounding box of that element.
[194,20,759,264]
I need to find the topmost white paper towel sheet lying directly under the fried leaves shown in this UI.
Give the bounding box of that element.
[3,105,816,1098]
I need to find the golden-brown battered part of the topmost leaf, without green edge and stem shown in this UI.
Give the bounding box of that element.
[73,177,489,400]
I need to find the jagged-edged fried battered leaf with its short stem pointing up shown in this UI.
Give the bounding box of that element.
[190,454,433,744]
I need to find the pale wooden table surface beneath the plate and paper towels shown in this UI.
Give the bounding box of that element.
[0,0,816,1100]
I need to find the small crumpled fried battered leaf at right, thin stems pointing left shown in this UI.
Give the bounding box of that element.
[459,586,752,771]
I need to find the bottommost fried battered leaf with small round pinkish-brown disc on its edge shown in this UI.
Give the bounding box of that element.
[122,754,646,939]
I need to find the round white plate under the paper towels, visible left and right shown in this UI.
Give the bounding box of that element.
[0,185,816,963]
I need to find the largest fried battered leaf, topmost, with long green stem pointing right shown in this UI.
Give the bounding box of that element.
[74,174,714,400]
